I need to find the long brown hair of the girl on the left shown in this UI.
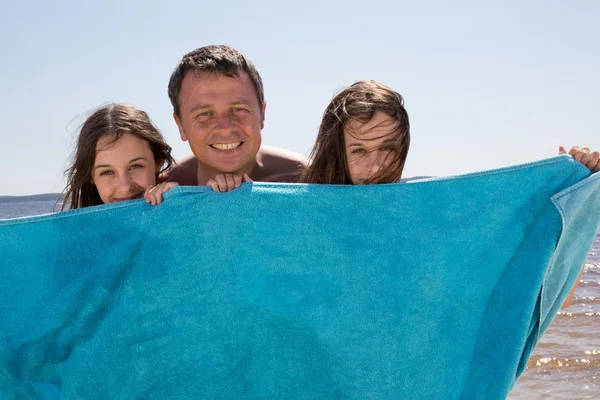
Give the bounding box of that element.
[61,104,175,210]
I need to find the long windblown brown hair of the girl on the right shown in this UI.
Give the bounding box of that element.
[300,81,410,185]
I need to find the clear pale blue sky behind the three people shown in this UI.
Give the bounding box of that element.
[0,0,600,195]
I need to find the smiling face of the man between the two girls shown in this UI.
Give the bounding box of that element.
[174,71,265,175]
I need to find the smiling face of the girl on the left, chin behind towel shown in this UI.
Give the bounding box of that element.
[92,133,159,204]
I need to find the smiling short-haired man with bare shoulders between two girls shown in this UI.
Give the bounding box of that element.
[162,45,305,187]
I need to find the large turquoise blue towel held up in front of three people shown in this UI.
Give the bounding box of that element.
[0,156,600,399]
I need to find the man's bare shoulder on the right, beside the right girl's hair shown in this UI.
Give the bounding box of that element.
[252,146,308,183]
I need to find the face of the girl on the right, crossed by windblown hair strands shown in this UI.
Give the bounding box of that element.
[344,111,399,185]
